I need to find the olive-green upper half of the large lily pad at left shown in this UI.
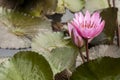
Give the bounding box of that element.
[0,9,51,36]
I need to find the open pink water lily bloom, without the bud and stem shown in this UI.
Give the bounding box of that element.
[68,11,105,39]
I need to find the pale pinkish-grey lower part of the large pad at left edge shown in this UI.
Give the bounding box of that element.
[0,23,31,49]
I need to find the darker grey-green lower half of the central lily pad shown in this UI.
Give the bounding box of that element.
[43,47,77,74]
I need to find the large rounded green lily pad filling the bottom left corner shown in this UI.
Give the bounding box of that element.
[0,51,53,80]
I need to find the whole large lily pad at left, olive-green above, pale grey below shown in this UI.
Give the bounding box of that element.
[0,10,51,49]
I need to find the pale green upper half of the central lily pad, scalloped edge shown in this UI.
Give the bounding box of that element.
[32,31,68,53]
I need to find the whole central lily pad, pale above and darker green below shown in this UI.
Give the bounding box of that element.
[32,31,77,74]
